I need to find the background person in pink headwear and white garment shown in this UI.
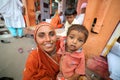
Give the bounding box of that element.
[76,3,87,25]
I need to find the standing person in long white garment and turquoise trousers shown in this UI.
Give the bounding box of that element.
[0,0,25,38]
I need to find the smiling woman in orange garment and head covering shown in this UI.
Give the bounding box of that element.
[23,22,60,80]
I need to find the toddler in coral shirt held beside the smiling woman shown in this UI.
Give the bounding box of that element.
[57,24,88,80]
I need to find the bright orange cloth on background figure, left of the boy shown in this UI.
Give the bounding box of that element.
[50,14,63,28]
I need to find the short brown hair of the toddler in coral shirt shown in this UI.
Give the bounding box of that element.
[67,24,89,42]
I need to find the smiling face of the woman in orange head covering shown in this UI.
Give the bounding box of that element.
[36,26,57,53]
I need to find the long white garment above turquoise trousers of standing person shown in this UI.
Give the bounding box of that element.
[0,0,25,28]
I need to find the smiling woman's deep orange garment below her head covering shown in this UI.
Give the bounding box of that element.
[23,41,60,80]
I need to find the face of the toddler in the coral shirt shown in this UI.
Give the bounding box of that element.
[66,30,85,52]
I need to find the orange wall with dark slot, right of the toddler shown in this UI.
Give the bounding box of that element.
[83,0,120,57]
